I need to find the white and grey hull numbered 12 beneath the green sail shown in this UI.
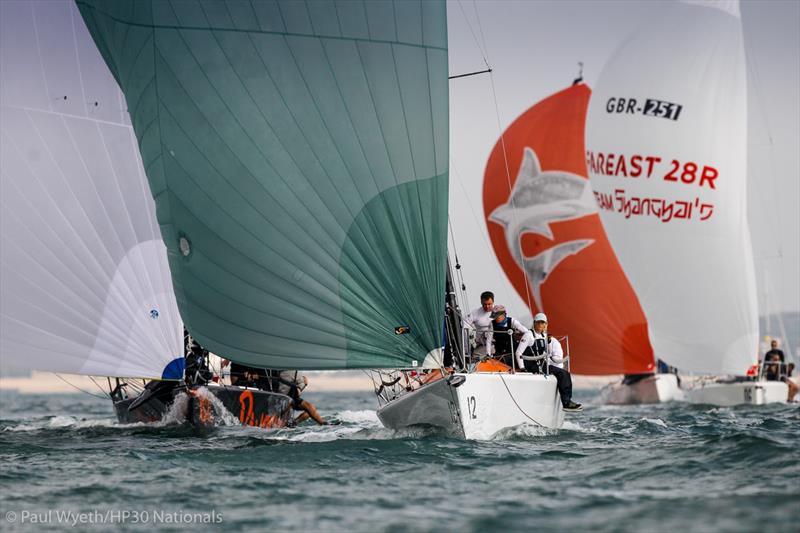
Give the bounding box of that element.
[378,373,564,439]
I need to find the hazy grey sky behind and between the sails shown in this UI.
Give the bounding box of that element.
[448,0,800,317]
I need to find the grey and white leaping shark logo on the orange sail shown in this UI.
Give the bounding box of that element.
[489,146,597,309]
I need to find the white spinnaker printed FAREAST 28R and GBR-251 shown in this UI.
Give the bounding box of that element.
[586,2,758,374]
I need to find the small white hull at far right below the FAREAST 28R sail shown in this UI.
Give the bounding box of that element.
[686,381,789,407]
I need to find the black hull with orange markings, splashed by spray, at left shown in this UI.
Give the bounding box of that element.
[114,386,292,428]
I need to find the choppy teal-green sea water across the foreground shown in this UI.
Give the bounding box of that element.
[0,392,800,531]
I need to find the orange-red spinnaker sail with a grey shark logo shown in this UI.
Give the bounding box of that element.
[483,84,655,375]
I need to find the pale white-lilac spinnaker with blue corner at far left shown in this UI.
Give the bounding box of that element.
[0,1,182,378]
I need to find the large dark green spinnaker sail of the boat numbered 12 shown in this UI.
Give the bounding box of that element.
[77,0,448,368]
